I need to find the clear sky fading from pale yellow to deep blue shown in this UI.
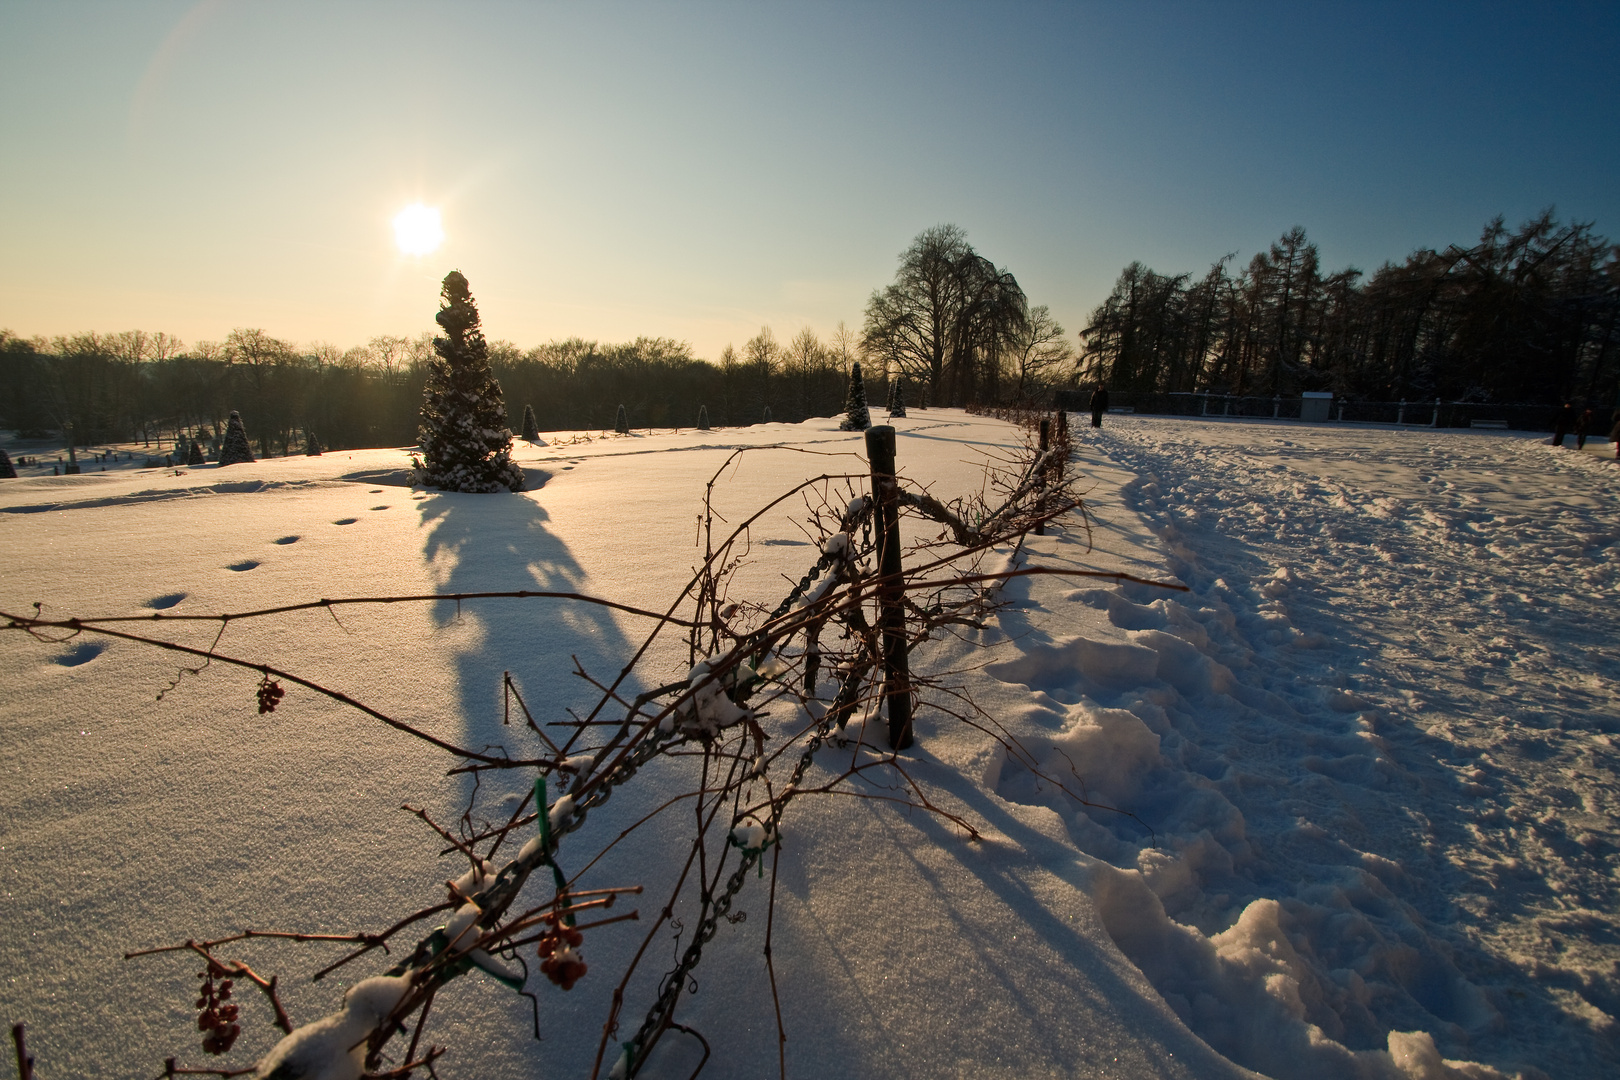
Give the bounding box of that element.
[0,0,1620,359]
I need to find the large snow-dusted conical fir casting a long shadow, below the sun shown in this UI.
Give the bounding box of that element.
[418,270,523,492]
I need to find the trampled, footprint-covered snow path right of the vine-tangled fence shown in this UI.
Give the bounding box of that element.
[1043,418,1620,1077]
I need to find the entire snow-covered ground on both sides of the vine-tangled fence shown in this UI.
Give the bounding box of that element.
[0,410,1620,1080]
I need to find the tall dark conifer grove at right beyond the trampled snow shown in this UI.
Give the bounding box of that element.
[1081,210,1620,406]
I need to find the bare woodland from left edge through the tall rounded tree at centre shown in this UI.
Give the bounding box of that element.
[0,225,1074,457]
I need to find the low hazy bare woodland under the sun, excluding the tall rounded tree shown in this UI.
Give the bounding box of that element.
[0,327,886,457]
